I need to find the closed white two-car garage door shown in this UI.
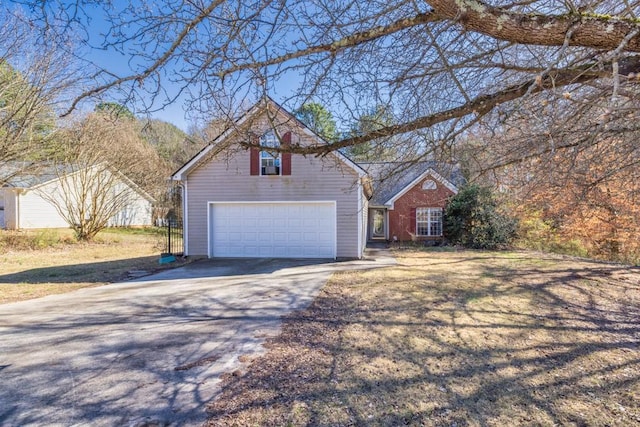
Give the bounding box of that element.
[209,202,336,258]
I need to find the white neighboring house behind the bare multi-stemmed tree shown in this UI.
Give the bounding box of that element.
[0,167,153,230]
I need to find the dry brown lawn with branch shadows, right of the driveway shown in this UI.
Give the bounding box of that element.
[209,251,640,426]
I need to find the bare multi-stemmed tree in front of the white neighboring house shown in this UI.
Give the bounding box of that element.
[39,114,169,240]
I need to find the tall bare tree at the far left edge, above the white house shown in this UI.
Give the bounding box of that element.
[0,7,78,186]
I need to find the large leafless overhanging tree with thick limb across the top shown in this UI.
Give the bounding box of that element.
[5,0,640,167]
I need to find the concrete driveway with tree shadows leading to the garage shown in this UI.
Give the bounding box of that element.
[0,251,395,426]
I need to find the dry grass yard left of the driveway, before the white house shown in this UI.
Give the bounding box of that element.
[0,230,185,304]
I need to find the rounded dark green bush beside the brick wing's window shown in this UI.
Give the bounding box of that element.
[444,184,517,249]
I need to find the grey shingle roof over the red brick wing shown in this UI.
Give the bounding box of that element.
[358,161,464,206]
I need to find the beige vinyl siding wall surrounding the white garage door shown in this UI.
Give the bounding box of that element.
[186,144,362,257]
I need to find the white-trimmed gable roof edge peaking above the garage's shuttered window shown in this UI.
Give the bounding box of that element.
[171,96,366,181]
